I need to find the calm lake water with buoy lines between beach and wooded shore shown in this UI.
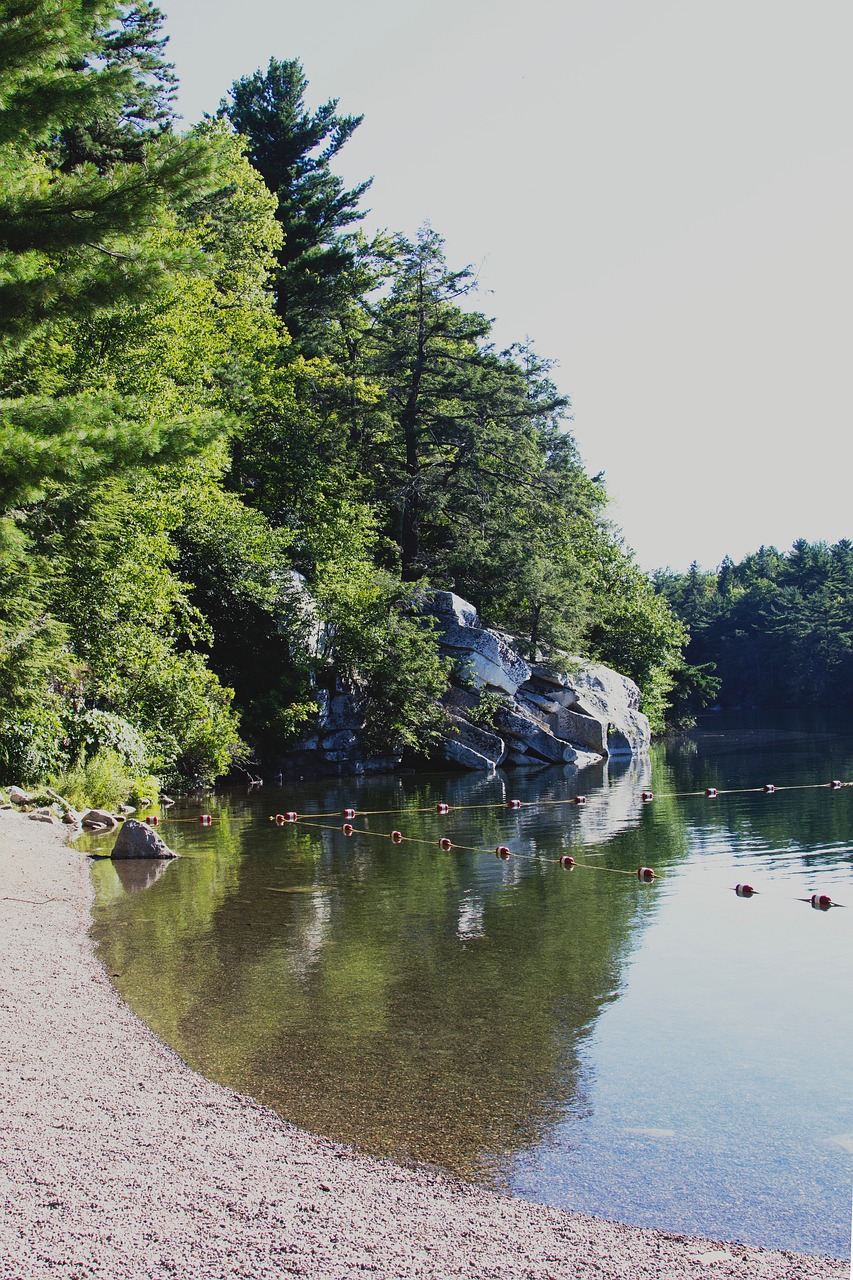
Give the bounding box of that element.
[87,718,853,1257]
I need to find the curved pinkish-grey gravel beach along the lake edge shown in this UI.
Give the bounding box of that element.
[0,810,850,1280]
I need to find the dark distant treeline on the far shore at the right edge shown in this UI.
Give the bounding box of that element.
[654,539,853,709]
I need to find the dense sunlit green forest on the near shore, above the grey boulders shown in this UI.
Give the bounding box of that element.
[0,0,698,782]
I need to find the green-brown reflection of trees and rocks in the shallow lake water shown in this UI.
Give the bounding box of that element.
[95,762,649,1176]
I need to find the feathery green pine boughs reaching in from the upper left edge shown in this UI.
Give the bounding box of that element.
[0,0,222,511]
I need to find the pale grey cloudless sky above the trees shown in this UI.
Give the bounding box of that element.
[160,0,853,570]
